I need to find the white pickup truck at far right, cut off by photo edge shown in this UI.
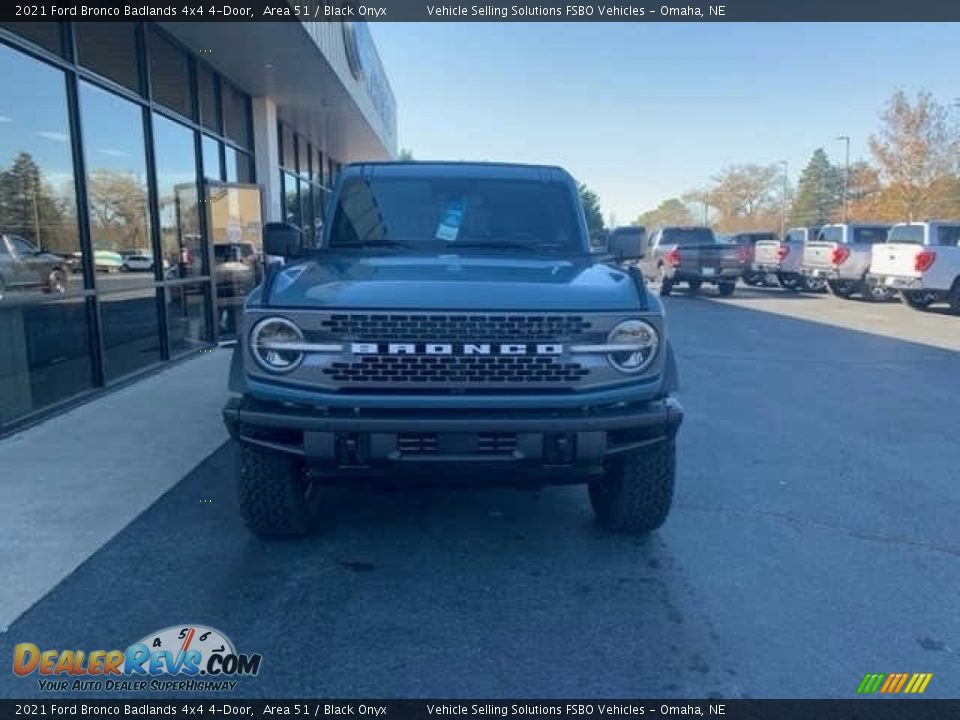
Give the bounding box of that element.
[868,220,960,314]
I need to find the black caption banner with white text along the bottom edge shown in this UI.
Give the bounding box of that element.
[0,698,960,720]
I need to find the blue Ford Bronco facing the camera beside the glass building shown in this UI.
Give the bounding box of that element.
[223,162,683,537]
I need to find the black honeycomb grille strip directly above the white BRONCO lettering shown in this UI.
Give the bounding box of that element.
[321,314,591,342]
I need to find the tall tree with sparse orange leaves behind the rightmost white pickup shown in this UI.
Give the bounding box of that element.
[868,90,957,220]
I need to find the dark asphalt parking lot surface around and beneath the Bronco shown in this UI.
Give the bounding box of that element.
[0,288,960,698]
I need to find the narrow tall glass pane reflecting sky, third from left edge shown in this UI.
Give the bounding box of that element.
[153,114,204,279]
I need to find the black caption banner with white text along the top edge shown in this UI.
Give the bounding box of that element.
[0,0,960,20]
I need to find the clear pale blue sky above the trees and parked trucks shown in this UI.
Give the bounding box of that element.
[370,22,960,222]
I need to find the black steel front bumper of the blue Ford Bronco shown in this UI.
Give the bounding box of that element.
[223,397,683,481]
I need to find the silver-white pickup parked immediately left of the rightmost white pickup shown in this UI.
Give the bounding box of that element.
[801,223,894,302]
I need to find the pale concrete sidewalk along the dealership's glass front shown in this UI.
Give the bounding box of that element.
[0,349,230,632]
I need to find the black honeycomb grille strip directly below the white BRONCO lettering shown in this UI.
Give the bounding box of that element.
[323,355,590,384]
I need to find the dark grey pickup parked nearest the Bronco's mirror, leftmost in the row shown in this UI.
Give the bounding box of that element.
[640,227,749,296]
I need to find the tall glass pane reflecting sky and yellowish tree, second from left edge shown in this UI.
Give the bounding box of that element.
[80,82,153,291]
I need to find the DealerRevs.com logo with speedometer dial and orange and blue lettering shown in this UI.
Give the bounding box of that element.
[13,625,261,692]
